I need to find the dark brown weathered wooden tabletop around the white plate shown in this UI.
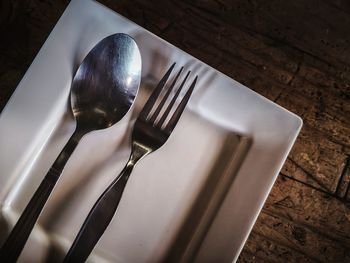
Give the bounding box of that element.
[0,0,350,262]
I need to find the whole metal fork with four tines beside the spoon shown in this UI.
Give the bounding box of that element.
[64,63,198,263]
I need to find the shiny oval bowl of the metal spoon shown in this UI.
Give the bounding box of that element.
[71,34,141,132]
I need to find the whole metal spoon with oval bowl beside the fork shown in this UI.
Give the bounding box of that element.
[0,34,141,262]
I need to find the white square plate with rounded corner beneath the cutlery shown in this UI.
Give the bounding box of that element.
[0,0,302,262]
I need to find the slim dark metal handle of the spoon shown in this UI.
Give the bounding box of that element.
[0,131,82,263]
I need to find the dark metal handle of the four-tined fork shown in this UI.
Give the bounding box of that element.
[64,162,133,263]
